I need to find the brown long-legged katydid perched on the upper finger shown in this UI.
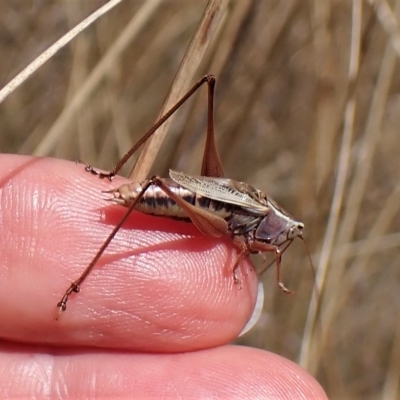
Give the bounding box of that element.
[57,75,304,315]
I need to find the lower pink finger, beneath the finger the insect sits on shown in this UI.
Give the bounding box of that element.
[0,346,327,399]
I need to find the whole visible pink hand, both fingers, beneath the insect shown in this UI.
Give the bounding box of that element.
[0,155,326,399]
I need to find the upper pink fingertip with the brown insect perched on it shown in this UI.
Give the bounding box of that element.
[0,155,257,352]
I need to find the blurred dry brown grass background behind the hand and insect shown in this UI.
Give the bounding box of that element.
[0,0,400,399]
